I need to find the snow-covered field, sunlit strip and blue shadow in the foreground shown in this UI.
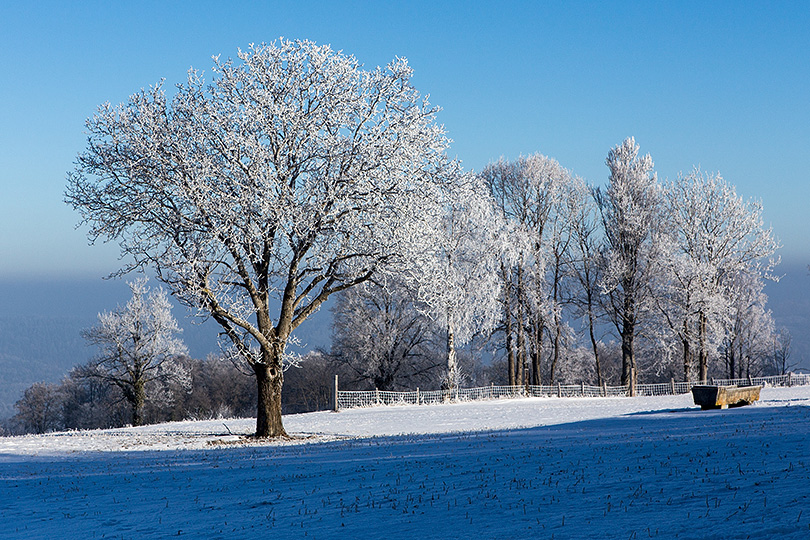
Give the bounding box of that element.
[0,387,810,539]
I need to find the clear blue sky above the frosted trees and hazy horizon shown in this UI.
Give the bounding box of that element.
[0,0,810,278]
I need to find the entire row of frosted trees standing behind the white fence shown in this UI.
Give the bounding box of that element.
[332,138,790,389]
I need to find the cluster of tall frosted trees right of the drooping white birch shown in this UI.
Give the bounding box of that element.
[483,138,778,384]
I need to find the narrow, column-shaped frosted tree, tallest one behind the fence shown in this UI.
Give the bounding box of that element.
[594,137,661,384]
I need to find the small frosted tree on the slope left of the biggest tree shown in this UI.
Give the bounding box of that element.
[82,278,190,426]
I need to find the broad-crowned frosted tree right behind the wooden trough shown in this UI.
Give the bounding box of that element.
[665,169,779,380]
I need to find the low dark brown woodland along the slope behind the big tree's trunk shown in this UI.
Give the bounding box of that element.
[0,351,505,435]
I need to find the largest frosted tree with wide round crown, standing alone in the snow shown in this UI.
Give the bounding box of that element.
[66,39,455,437]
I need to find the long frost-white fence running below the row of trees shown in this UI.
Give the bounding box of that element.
[334,373,810,410]
